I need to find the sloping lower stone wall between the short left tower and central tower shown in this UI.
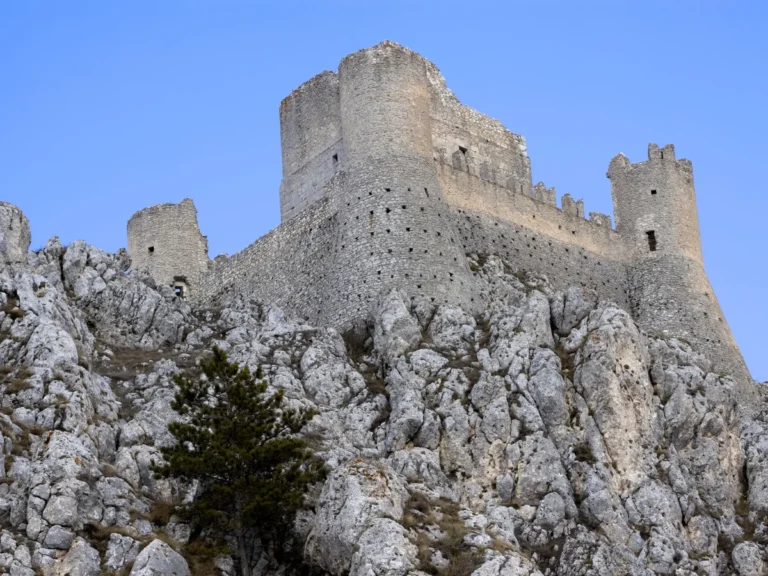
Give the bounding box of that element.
[201,195,336,322]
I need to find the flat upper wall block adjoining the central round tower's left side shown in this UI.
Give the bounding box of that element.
[280,71,346,221]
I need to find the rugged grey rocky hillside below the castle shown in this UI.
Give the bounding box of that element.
[0,204,768,576]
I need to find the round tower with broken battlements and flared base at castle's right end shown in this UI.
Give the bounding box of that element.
[608,144,749,379]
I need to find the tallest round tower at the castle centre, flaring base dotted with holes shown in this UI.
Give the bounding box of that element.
[327,42,475,325]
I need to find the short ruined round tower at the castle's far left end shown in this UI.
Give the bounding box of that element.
[128,198,208,298]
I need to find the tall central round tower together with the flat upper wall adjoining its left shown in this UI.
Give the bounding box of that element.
[280,42,475,326]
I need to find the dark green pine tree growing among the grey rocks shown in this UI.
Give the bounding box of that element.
[154,348,325,576]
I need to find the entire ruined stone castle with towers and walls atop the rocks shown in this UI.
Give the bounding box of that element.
[128,42,748,382]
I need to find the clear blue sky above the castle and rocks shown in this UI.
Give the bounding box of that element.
[0,0,768,380]
